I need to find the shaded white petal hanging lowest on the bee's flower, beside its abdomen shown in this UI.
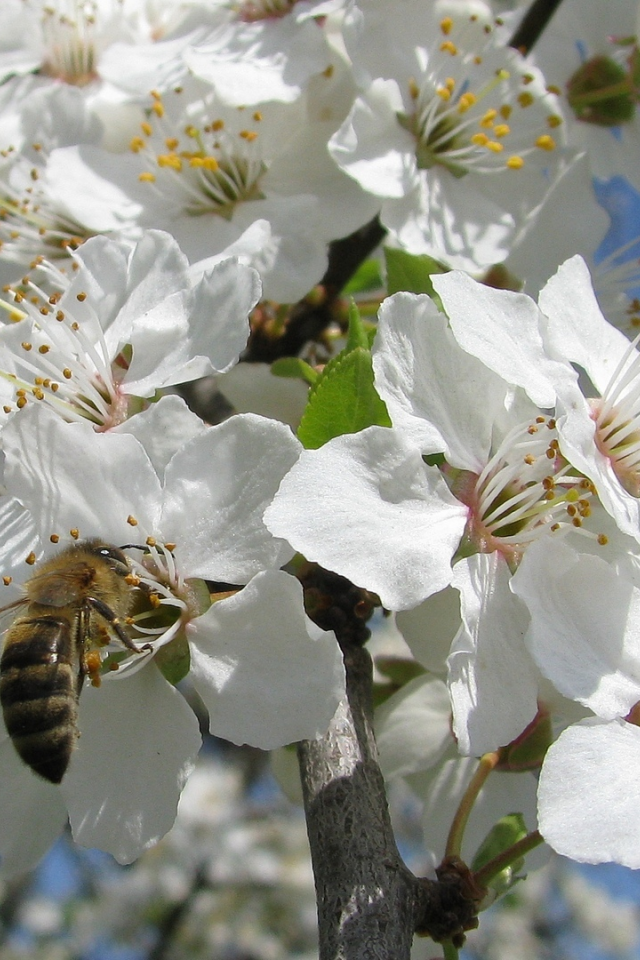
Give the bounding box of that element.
[61,664,201,863]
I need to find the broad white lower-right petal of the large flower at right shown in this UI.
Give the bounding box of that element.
[511,537,640,720]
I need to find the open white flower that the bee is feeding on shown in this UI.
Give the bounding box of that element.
[0,408,344,871]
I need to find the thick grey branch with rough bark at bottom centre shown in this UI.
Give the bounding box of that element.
[299,647,421,960]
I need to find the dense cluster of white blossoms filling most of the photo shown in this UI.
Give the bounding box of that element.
[0,0,640,908]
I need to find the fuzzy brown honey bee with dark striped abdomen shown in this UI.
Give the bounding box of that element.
[0,539,148,783]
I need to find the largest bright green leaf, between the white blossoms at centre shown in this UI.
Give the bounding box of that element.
[298,347,391,450]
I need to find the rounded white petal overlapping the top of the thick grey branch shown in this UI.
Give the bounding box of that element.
[189,571,344,750]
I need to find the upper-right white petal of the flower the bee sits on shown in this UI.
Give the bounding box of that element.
[163,413,300,583]
